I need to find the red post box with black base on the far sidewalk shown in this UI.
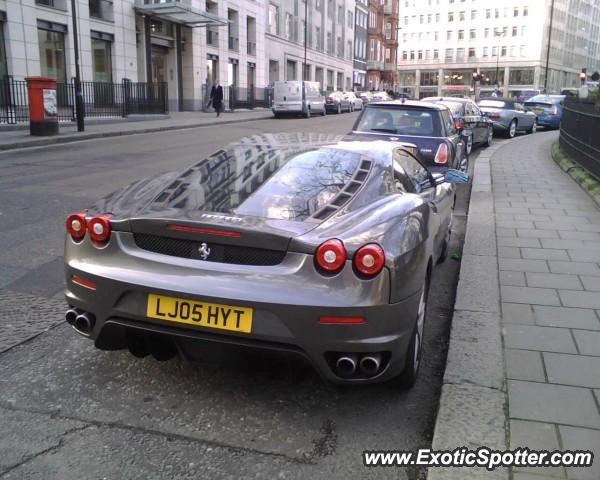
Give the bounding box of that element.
[25,77,58,136]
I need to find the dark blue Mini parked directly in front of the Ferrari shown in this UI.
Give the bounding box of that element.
[351,100,469,171]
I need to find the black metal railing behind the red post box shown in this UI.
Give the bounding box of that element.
[0,77,169,124]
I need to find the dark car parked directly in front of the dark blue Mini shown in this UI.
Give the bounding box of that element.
[422,97,494,155]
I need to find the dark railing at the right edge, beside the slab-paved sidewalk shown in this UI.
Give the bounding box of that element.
[559,97,600,179]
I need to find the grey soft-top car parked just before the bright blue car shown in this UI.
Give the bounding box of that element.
[477,97,537,138]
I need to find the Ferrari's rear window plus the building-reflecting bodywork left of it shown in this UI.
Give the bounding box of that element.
[153,144,361,221]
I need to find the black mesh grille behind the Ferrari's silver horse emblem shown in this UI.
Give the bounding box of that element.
[133,233,285,265]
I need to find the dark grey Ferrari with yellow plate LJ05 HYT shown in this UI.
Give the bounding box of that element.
[64,134,455,387]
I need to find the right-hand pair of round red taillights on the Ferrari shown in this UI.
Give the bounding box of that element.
[315,238,385,277]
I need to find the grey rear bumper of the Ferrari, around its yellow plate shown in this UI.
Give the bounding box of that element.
[65,234,419,383]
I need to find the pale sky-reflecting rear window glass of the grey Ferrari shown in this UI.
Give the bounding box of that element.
[233,148,361,220]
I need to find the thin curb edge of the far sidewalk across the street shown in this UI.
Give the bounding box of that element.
[0,112,273,151]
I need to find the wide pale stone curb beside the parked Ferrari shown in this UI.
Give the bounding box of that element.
[427,140,514,480]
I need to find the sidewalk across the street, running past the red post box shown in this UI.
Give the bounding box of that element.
[0,108,273,150]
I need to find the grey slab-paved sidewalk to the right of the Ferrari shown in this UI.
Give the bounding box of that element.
[490,132,600,480]
